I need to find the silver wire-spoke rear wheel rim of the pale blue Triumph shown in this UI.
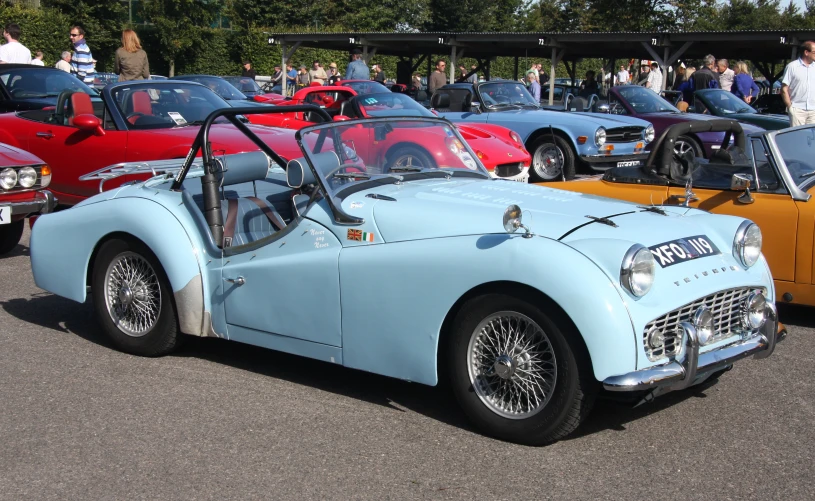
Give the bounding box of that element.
[104,252,162,337]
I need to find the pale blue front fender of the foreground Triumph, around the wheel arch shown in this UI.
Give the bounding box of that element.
[340,234,637,385]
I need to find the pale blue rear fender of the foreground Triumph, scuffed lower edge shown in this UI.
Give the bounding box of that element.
[30,197,210,335]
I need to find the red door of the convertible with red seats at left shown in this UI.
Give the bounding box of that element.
[21,112,127,205]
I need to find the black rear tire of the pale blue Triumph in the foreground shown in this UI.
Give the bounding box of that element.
[91,239,180,357]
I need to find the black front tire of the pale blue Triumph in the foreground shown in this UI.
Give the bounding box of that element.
[446,294,594,445]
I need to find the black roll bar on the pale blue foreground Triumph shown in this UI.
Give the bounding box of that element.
[170,104,331,245]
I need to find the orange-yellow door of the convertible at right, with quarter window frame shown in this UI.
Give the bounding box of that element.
[669,138,798,282]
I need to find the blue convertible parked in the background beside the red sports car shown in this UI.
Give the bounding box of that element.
[431,80,654,182]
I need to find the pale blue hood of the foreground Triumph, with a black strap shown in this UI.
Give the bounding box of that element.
[366,179,724,246]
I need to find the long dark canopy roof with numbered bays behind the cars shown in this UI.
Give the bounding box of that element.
[268,30,815,96]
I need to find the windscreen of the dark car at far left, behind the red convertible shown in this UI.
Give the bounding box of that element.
[0,68,99,100]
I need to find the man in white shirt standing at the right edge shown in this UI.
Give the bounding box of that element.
[781,40,815,127]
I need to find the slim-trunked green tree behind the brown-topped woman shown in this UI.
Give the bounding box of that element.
[142,0,222,76]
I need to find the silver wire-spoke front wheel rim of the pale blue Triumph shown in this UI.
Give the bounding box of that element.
[467,311,557,419]
